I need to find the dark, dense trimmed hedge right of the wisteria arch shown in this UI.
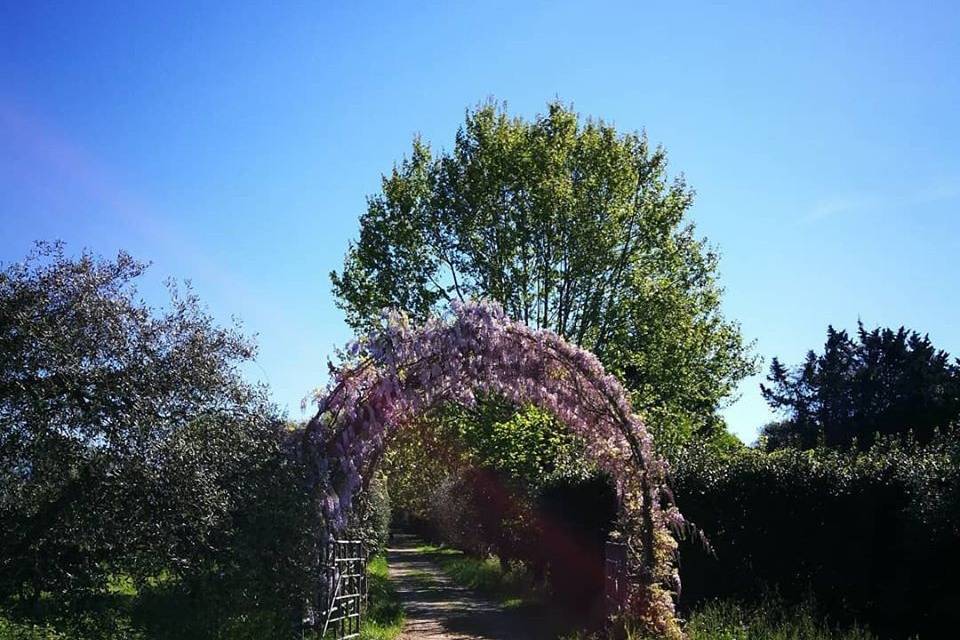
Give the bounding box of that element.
[674,435,960,637]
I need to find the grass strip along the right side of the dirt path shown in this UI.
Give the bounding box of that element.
[417,544,543,609]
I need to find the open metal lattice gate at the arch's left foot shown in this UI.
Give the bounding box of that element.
[316,539,367,640]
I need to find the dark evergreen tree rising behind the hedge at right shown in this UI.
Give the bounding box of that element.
[761,323,960,449]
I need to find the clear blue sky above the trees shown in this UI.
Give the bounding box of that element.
[0,1,960,441]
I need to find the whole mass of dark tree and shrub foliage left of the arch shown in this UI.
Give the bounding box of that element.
[0,245,316,638]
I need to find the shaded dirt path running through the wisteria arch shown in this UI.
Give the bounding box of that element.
[387,535,554,640]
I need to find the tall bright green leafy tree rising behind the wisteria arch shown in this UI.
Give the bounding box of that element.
[330,103,754,442]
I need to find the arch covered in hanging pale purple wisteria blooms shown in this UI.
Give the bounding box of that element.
[303,303,683,637]
